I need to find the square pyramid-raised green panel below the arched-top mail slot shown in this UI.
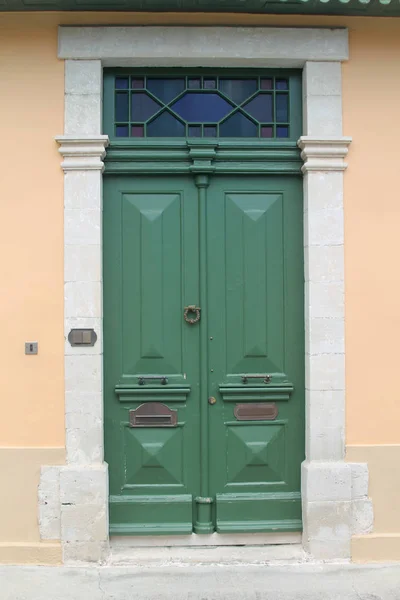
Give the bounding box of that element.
[125,427,183,487]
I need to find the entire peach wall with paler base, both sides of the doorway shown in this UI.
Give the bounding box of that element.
[0,8,400,562]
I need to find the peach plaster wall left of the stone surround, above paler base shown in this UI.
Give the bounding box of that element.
[0,15,64,447]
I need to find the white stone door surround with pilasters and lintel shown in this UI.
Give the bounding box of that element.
[44,26,371,563]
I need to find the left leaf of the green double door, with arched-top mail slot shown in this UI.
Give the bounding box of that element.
[104,177,199,534]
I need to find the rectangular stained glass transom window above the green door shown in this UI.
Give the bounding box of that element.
[114,75,291,139]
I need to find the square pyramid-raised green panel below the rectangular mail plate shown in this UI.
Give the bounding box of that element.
[227,425,285,484]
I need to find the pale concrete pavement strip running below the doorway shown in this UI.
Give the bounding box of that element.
[0,549,400,600]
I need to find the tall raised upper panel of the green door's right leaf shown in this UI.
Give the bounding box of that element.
[225,190,283,377]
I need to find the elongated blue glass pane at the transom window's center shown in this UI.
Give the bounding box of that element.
[172,92,232,122]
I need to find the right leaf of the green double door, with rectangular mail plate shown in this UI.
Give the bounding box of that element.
[207,176,304,532]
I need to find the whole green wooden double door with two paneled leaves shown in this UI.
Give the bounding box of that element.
[104,175,304,535]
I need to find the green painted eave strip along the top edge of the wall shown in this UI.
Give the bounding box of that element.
[0,0,400,17]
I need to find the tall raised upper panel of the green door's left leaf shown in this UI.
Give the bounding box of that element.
[121,190,195,383]
